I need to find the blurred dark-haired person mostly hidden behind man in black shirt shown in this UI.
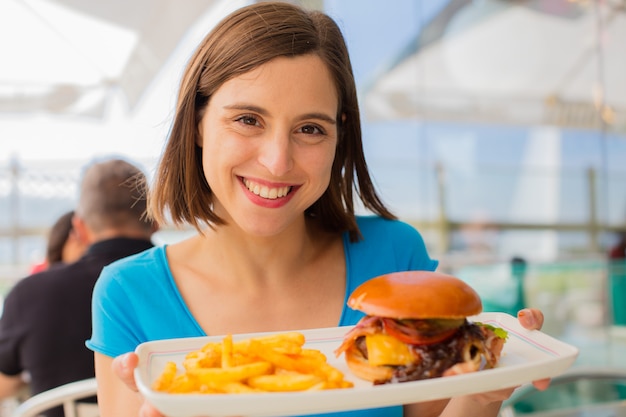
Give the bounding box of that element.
[30,210,87,274]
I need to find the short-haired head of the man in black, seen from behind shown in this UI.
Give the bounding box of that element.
[76,159,153,236]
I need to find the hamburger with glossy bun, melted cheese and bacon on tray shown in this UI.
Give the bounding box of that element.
[335,271,506,384]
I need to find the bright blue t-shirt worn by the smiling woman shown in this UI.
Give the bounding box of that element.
[87,216,437,417]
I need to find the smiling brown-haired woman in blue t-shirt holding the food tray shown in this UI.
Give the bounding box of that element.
[87,2,543,417]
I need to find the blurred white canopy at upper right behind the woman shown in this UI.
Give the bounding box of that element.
[364,0,626,131]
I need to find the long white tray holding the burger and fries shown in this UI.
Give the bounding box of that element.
[135,313,578,417]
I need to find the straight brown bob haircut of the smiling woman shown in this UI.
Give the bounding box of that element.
[149,2,395,241]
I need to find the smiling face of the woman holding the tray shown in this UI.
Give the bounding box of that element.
[199,55,338,236]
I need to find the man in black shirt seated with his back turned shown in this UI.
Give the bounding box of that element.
[0,159,156,417]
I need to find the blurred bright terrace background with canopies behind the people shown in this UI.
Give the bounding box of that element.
[0,0,626,374]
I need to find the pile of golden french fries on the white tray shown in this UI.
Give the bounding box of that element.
[152,332,353,394]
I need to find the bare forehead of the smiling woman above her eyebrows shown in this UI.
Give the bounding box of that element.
[210,55,339,112]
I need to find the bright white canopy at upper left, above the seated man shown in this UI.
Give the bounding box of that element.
[0,0,221,117]
